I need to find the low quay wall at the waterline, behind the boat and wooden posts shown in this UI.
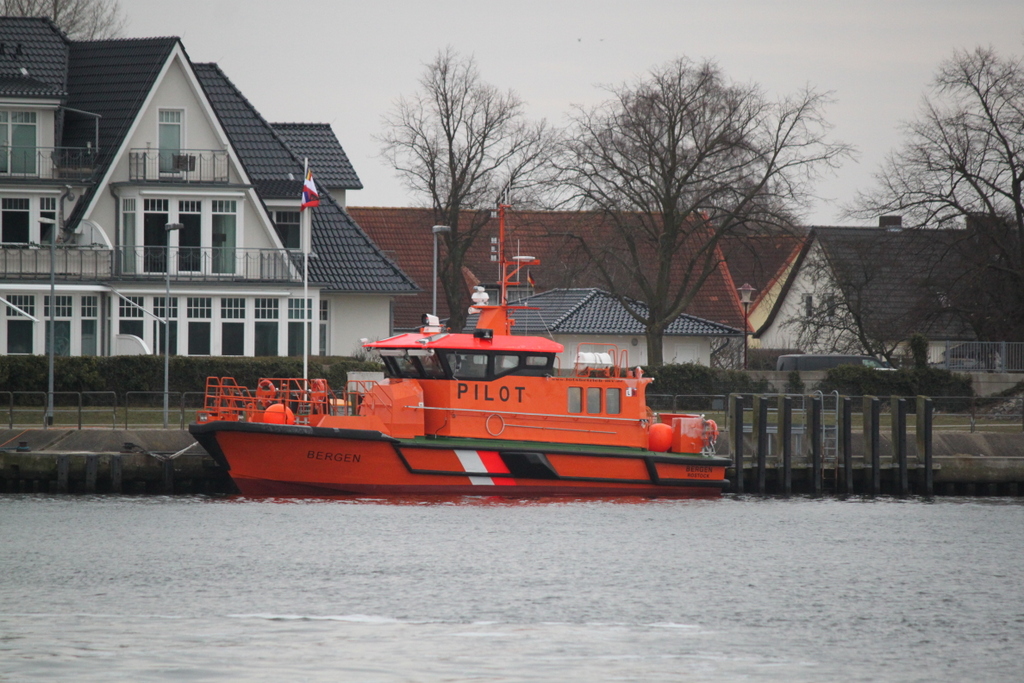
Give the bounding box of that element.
[0,429,1024,496]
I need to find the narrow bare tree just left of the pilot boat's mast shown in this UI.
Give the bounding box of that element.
[379,48,551,330]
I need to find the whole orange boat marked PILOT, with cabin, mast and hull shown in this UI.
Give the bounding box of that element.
[189,202,731,497]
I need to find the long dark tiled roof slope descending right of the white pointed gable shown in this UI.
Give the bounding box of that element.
[195,63,417,293]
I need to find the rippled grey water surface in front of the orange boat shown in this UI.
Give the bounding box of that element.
[0,495,1024,682]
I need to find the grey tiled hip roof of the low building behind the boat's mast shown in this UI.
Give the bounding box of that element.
[468,288,742,337]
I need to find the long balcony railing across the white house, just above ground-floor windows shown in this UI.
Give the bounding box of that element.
[0,245,302,283]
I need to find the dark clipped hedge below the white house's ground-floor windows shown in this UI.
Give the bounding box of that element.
[0,355,382,396]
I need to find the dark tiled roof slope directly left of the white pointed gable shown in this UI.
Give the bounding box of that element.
[63,38,178,226]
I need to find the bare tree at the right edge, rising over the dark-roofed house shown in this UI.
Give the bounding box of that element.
[851,48,1024,341]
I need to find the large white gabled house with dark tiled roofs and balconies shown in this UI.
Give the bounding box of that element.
[0,17,418,355]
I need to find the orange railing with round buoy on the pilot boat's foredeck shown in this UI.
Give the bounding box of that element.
[196,377,344,425]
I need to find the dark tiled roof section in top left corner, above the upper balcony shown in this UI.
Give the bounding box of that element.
[0,16,69,97]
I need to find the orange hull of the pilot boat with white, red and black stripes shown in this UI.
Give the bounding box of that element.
[189,422,730,498]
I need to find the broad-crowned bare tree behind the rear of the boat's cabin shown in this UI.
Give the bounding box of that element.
[559,58,850,365]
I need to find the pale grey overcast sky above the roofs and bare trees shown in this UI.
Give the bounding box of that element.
[121,0,1024,224]
